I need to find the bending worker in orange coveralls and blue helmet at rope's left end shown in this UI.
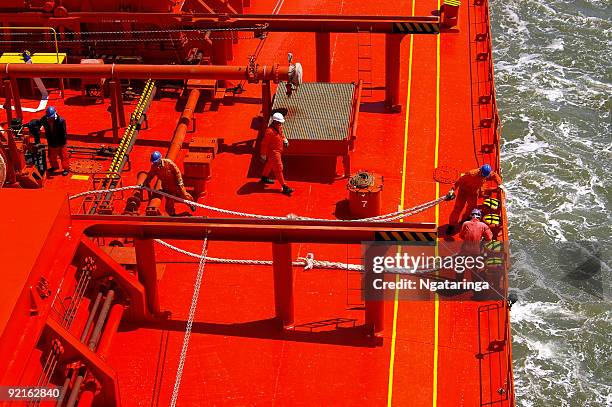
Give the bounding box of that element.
[143,151,196,216]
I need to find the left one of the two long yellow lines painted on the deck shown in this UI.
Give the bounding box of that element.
[387,0,415,407]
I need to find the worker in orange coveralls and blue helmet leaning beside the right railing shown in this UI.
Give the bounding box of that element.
[447,164,502,233]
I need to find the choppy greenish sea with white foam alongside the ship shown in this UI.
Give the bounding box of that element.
[491,0,612,407]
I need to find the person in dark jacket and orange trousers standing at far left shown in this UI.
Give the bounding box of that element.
[27,106,70,176]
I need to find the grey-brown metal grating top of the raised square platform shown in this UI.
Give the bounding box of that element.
[272,82,355,141]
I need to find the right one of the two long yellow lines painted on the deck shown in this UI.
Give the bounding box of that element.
[431,0,440,407]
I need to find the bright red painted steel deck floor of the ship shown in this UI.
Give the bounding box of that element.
[1,0,511,407]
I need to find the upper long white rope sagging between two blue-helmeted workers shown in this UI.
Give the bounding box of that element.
[69,185,448,222]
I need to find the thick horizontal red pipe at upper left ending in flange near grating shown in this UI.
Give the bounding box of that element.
[0,64,289,83]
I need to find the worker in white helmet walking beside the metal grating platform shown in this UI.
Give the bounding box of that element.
[260,112,293,195]
